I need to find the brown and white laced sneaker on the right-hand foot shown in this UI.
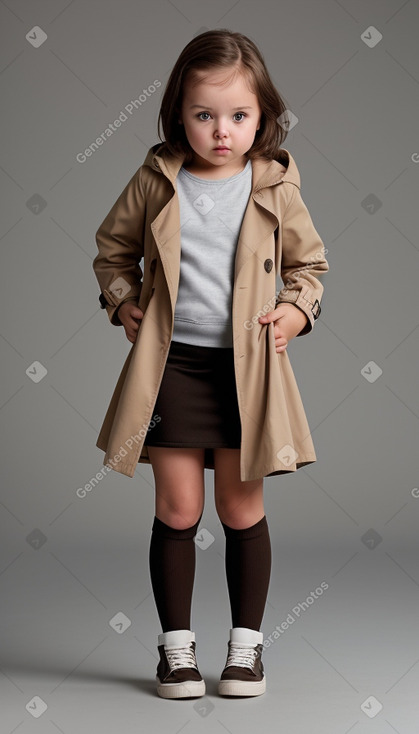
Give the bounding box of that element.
[218,627,266,696]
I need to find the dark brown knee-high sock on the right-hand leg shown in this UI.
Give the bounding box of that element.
[221,515,272,631]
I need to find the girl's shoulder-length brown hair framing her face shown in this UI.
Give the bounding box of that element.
[158,28,288,165]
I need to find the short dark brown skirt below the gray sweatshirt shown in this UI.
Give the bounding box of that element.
[144,341,241,448]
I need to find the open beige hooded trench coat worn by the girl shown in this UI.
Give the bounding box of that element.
[93,143,329,481]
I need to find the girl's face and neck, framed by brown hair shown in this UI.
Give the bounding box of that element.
[179,69,262,178]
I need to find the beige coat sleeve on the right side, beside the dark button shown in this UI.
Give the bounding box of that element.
[275,185,329,336]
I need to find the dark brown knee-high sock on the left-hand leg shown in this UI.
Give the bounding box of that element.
[149,516,201,632]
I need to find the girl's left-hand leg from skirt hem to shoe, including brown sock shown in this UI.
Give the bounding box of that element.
[148,446,205,632]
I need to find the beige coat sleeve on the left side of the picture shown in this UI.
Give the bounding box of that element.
[92,167,145,326]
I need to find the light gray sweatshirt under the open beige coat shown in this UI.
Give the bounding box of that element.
[172,160,252,347]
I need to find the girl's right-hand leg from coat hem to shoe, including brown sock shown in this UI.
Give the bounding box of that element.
[214,448,271,631]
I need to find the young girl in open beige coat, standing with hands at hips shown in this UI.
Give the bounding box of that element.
[93,29,329,698]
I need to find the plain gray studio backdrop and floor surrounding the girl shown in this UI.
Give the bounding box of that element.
[0,0,419,734]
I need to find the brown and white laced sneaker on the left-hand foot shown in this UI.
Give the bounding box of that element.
[156,630,205,698]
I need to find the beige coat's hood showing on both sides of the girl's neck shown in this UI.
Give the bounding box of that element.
[144,143,300,194]
